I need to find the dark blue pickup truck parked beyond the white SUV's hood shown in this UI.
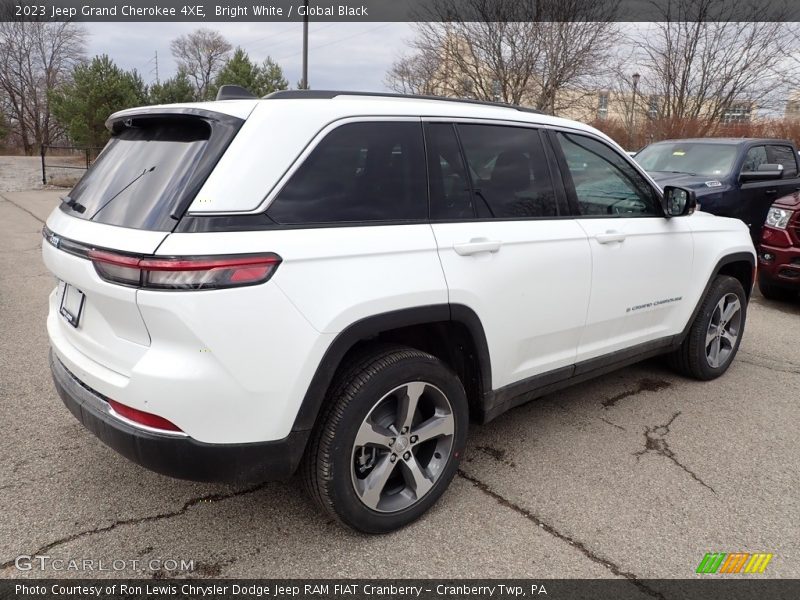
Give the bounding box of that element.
[636,138,800,243]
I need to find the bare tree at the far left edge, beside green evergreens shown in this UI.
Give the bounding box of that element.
[0,21,86,154]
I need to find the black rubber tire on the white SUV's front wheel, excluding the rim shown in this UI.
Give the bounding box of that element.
[669,275,747,381]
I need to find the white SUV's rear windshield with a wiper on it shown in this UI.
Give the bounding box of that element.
[61,118,216,231]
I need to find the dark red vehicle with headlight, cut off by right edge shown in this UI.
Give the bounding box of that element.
[758,192,800,300]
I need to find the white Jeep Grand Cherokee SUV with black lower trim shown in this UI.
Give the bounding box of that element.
[43,92,755,532]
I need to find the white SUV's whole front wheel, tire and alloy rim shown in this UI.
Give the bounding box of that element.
[670,275,747,380]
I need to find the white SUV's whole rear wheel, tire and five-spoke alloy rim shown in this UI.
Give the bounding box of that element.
[303,347,468,533]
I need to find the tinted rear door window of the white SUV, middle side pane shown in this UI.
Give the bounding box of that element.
[457,124,558,219]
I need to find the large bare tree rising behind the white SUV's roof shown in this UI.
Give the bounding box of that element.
[386,0,619,112]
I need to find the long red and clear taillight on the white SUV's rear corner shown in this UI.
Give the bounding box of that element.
[88,250,281,290]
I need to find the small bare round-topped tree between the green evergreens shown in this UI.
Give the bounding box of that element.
[170,28,232,100]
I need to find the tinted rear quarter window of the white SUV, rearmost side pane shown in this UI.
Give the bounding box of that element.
[267,121,428,224]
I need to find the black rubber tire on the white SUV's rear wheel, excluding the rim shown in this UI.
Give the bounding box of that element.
[301,345,469,533]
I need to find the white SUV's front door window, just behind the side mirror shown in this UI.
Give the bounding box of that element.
[556,132,664,217]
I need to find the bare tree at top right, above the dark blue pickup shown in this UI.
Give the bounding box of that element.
[636,0,797,135]
